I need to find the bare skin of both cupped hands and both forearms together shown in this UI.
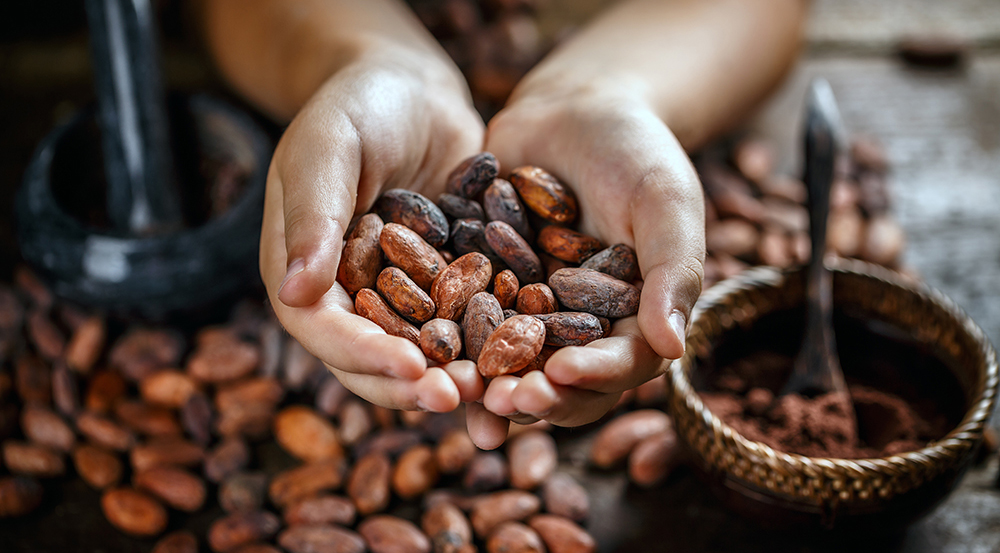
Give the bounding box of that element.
[205,0,806,448]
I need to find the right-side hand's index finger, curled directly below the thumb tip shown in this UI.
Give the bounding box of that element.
[544,317,664,393]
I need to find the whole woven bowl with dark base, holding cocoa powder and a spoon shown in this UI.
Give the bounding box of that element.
[668,260,998,529]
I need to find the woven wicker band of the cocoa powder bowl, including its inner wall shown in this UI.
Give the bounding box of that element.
[668,260,998,509]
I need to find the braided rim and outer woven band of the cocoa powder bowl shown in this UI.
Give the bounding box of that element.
[668,258,1000,507]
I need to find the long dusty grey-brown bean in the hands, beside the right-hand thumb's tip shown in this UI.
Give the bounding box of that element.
[549,268,639,319]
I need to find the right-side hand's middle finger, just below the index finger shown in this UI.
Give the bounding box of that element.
[511,371,621,426]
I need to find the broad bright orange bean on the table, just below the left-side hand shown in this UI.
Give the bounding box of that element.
[274,405,344,463]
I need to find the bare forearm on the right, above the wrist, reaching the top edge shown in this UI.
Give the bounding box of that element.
[511,0,807,150]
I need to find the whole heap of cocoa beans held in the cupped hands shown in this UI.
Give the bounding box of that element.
[337,152,639,378]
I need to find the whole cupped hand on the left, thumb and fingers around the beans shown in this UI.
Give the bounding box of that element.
[260,48,483,411]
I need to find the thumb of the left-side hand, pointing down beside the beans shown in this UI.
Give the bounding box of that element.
[272,112,361,307]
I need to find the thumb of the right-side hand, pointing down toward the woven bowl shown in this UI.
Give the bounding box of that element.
[631,136,705,359]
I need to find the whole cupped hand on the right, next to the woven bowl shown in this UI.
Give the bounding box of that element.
[468,88,705,447]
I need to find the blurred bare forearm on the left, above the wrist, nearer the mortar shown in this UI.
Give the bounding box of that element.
[204,0,461,120]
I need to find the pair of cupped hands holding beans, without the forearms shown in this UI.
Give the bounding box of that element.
[260,52,705,449]
